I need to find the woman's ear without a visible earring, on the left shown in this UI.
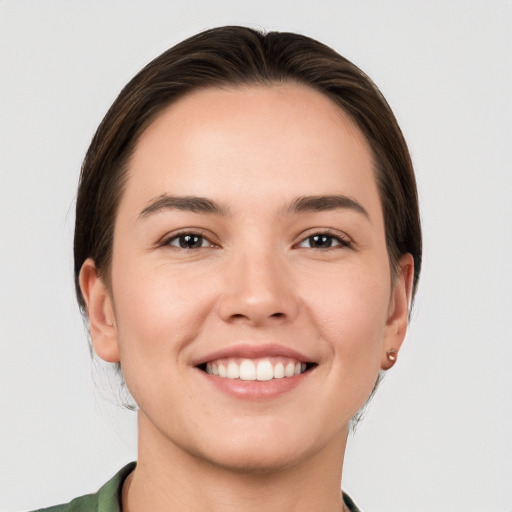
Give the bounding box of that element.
[79,258,120,363]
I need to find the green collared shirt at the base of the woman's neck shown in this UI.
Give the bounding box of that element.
[34,462,359,512]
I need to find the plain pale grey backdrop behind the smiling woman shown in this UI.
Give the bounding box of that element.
[0,0,512,512]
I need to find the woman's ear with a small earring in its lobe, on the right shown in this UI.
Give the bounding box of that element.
[380,254,414,370]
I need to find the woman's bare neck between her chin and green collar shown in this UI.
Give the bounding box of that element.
[122,416,346,512]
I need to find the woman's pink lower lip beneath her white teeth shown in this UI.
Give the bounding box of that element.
[198,370,312,400]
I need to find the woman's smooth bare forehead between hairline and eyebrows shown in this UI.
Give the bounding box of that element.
[122,83,378,218]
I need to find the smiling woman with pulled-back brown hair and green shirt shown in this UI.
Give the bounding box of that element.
[41,27,421,512]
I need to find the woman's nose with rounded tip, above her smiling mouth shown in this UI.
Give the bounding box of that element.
[219,249,299,326]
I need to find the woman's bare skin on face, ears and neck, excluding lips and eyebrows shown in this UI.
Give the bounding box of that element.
[80,84,413,512]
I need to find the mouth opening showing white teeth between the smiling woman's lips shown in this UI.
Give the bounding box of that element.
[198,357,317,381]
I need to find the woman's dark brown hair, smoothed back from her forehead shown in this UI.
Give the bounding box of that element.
[74,27,421,311]
